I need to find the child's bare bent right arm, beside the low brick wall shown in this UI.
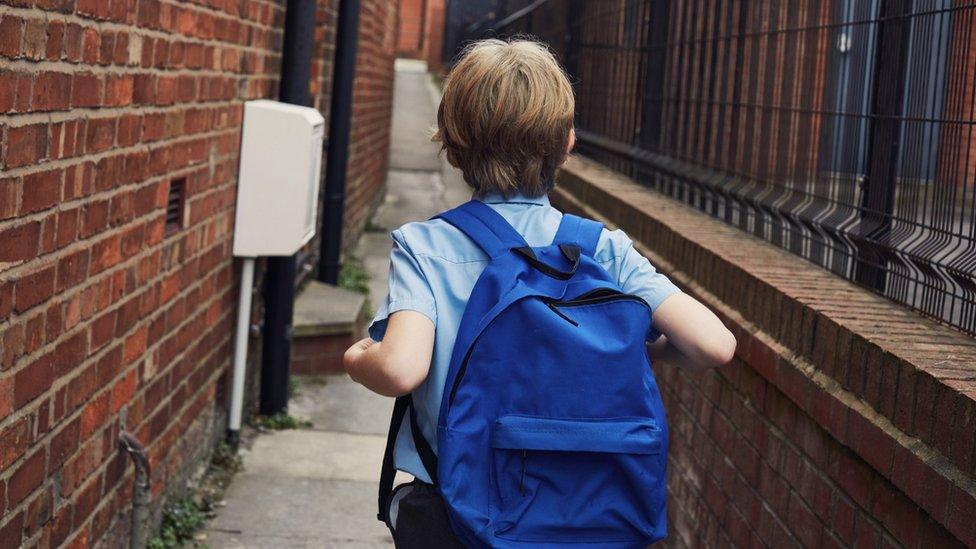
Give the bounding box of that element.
[651,293,735,370]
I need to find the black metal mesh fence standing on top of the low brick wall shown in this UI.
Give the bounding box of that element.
[454,0,976,334]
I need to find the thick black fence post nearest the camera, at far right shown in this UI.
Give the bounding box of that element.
[854,0,912,292]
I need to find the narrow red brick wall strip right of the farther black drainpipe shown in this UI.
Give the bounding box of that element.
[342,0,397,249]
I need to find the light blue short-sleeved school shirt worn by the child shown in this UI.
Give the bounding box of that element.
[369,191,680,483]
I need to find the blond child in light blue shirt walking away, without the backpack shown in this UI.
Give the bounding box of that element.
[344,40,735,547]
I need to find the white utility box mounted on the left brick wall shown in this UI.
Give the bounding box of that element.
[234,99,325,257]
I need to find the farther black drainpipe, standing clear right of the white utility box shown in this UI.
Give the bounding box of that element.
[318,0,359,284]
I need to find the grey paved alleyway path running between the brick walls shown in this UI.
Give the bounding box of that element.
[205,60,470,549]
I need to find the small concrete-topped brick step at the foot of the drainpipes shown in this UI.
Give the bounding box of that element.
[291,281,366,374]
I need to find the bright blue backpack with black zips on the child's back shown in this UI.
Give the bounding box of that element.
[379,200,668,548]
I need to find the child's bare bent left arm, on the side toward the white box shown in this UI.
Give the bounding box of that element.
[342,310,434,396]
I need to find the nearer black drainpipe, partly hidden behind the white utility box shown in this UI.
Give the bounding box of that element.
[261,0,315,415]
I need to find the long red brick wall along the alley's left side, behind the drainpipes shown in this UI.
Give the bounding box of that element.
[0,0,396,547]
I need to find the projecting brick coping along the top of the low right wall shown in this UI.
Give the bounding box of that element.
[552,157,976,545]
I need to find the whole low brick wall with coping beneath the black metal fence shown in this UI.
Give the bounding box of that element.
[553,158,976,547]
